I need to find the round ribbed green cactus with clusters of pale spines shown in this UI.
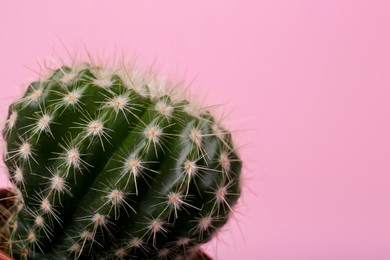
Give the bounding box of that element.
[1,63,242,259]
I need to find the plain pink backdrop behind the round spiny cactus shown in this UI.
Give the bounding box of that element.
[0,0,390,260]
